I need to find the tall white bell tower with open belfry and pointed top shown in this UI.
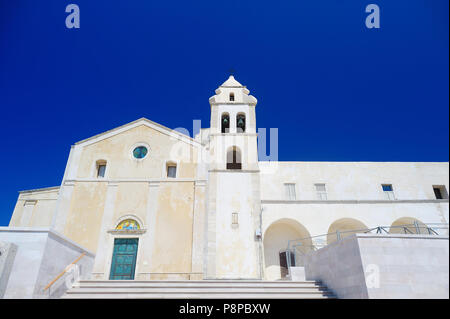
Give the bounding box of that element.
[204,75,262,279]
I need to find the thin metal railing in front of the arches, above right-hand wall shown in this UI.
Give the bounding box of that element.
[286,221,449,276]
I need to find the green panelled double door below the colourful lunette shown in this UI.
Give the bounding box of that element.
[109,238,139,280]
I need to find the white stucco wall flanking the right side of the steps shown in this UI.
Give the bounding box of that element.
[305,234,449,299]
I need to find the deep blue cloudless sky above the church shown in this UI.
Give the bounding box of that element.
[0,0,449,225]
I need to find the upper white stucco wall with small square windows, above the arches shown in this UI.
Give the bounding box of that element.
[259,162,449,200]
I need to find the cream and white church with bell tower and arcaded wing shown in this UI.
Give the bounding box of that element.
[0,76,449,298]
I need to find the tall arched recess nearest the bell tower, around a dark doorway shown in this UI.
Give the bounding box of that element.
[263,218,313,280]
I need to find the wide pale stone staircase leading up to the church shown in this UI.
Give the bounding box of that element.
[62,280,335,299]
